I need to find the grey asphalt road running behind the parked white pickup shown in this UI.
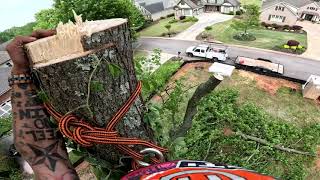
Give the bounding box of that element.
[136,38,320,80]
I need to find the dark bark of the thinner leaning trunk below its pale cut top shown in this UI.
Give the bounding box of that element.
[170,76,223,140]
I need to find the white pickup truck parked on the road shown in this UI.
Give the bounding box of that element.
[186,44,228,61]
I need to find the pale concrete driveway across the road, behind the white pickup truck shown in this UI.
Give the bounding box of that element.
[172,13,233,41]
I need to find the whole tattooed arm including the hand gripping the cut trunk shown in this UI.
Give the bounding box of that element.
[7,31,79,180]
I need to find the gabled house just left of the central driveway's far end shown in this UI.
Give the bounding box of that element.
[174,0,204,19]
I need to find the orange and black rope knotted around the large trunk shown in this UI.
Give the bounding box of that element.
[44,81,168,169]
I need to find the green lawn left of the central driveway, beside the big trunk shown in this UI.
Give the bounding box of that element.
[139,17,194,37]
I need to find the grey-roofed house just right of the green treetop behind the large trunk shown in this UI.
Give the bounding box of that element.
[134,0,176,21]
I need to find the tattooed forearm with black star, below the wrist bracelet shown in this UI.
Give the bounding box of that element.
[12,83,78,179]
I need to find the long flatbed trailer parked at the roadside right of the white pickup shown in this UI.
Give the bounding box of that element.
[235,56,284,75]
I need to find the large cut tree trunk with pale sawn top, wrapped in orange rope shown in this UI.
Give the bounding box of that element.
[26,19,154,165]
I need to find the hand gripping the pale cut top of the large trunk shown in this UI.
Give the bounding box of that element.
[6,30,56,74]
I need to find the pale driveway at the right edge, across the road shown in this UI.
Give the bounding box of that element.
[297,21,320,60]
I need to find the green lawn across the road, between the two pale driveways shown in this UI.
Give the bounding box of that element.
[205,20,307,49]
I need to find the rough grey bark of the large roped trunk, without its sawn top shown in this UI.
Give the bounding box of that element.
[30,23,153,161]
